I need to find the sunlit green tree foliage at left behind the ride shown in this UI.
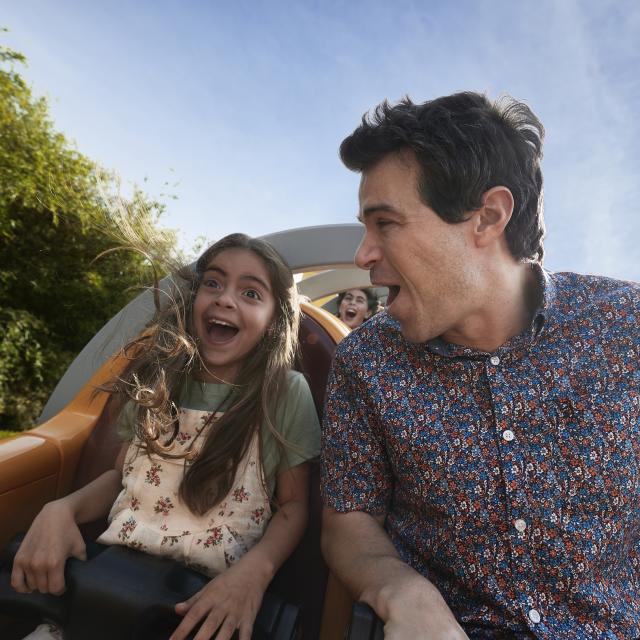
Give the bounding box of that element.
[0,38,175,429]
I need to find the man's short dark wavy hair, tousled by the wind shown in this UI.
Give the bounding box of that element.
[340,92,544,262]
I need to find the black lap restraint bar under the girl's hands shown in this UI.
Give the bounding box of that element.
[0,536,300,640]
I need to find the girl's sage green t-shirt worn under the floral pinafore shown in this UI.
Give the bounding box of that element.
[117,371,320,494]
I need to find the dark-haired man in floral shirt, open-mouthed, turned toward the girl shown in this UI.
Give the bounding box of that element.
[323,93,640,640]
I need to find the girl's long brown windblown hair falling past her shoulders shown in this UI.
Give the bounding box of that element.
[105,233,300,514]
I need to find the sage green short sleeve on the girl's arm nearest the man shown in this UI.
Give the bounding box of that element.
[263,371,320,477]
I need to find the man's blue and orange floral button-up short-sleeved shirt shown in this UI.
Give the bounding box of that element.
[322,270,640,640]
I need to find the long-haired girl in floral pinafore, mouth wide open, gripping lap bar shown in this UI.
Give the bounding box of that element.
[11,234,319,640]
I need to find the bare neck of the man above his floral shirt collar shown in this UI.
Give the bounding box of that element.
[441,263,542,353]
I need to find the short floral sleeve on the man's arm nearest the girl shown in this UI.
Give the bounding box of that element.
[321,341,392,514]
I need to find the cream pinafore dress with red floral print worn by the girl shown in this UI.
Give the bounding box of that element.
[98,409,271,576]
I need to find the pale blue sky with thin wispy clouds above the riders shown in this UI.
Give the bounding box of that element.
[0,0,640,280]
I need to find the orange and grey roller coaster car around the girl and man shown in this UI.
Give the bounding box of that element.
[0,225,373,640]
